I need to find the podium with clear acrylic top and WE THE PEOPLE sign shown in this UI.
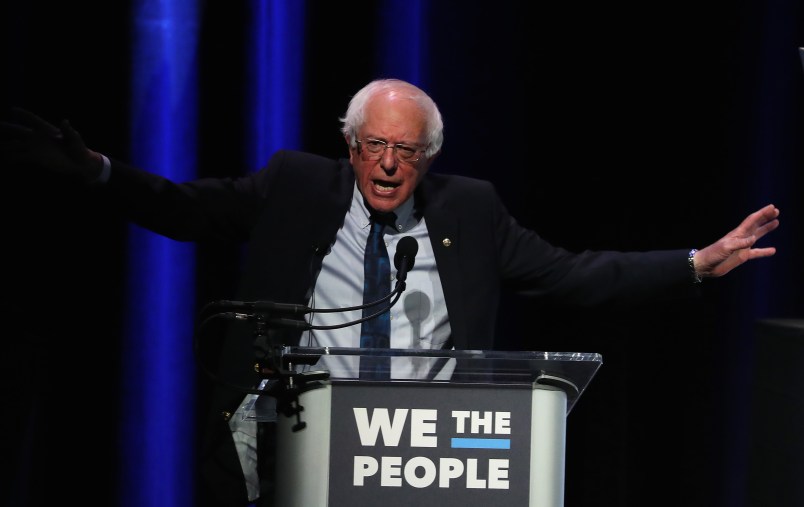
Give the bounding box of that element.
[261,347,602,507]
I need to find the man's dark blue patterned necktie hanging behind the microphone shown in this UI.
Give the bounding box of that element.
[360,213,396,380]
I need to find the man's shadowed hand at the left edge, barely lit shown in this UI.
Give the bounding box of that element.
[0,108,103,183]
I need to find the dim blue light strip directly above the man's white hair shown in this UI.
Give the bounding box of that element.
[375,0,430,87]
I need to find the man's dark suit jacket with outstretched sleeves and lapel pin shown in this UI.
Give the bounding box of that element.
[105,151,692,505]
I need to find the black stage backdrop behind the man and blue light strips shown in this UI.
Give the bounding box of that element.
[0,0,804,507]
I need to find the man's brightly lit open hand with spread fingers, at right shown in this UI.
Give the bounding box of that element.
[693,204,779,277]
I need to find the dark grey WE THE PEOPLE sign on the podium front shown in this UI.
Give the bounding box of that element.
[329,383,531,507]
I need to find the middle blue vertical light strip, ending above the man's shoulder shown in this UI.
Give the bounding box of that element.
[245,0,305,169]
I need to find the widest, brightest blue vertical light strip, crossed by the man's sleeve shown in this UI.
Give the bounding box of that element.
[119,0,198,507]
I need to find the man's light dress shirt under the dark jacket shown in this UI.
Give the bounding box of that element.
[229,185,454,500]
